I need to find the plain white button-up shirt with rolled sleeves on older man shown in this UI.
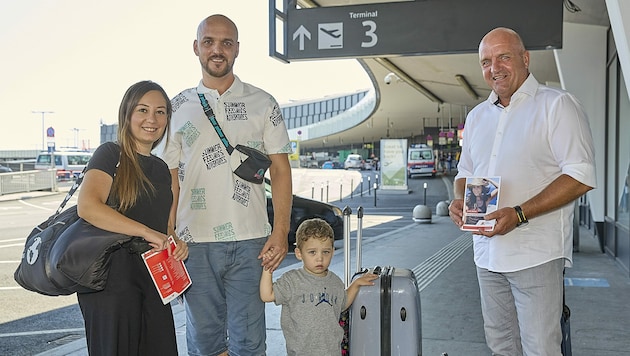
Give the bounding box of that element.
[455,74,596,272]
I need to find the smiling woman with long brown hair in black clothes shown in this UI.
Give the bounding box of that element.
[77,81,188,356]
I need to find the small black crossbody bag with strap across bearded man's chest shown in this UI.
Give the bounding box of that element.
[197,93,271,184]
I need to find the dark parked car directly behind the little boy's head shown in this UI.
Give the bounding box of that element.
[264,178,343,247]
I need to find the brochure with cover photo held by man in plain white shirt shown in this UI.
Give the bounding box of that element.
[461,177,501,231]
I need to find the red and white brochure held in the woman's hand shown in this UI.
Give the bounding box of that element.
[142,236,192,305]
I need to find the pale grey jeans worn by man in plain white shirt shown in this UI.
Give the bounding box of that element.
[477,259,564,356]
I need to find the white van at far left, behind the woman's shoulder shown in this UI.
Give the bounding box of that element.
[35,151,92,180]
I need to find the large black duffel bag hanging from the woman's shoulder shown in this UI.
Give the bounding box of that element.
[13,169,132,296]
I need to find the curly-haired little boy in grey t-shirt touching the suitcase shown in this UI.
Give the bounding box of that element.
[260,218,377,356]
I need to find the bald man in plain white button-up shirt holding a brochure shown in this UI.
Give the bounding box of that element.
[449,28,596,356]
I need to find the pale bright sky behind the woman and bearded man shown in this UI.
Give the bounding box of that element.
[0,0,372,150]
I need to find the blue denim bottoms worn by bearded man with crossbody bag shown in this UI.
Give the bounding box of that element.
[184,237,267,356]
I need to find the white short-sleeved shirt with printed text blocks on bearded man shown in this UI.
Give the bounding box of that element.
[156,77,292,242]
